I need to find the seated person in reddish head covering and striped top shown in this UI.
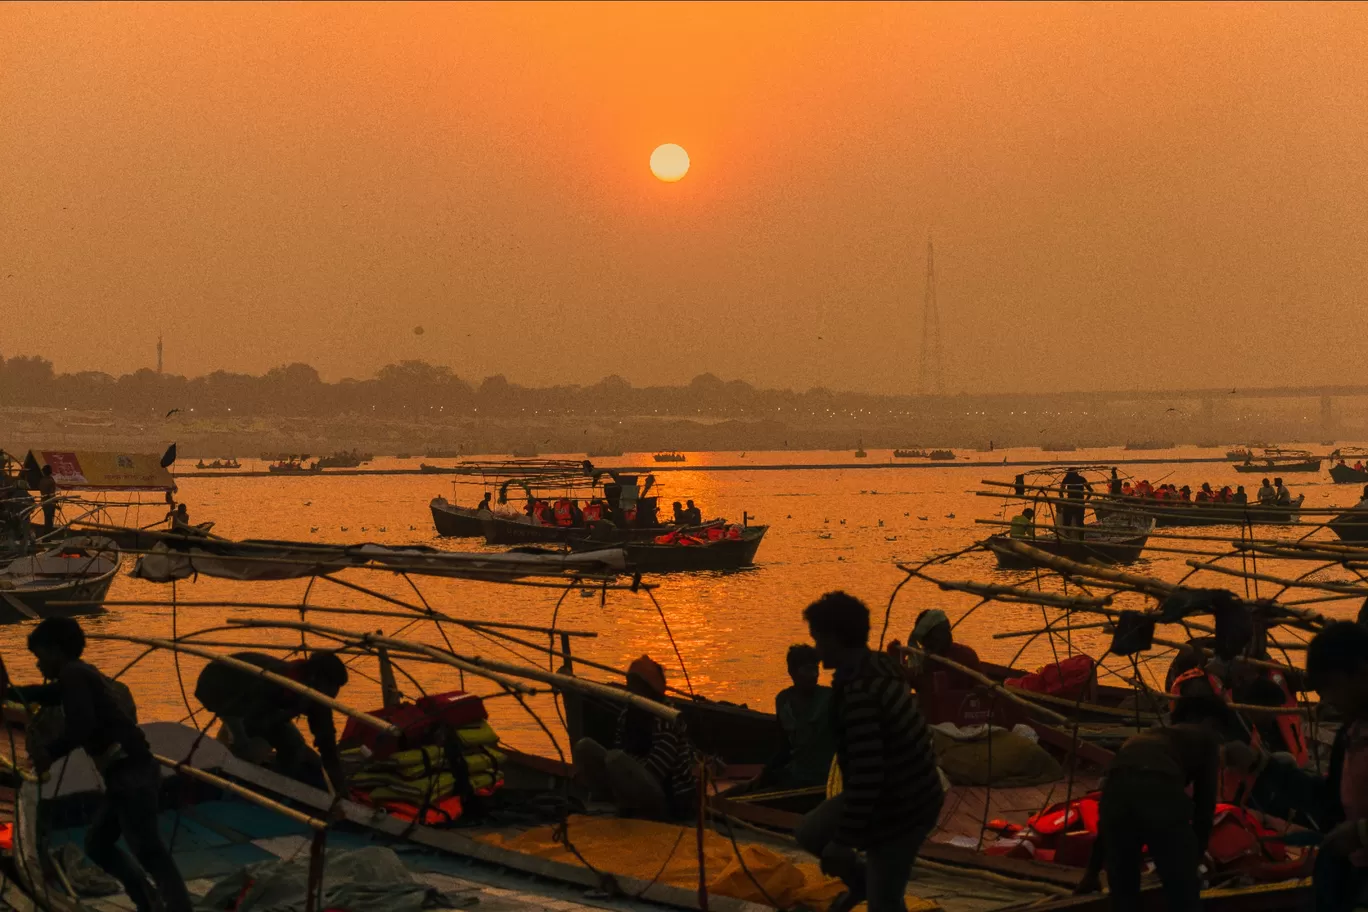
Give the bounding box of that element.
[572,655,698,820]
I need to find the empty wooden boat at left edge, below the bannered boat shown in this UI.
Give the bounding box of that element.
[0,537,123,623]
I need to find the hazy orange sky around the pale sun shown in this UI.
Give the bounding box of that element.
[8,3,1368,394]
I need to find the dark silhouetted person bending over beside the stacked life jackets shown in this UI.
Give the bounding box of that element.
[194,652,347,796]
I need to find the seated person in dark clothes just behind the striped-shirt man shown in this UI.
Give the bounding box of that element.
[748,644,836,790]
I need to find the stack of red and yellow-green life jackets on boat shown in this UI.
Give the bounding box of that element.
[341,690,505,826]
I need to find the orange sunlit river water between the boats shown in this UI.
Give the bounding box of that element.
[0,448,1358,752]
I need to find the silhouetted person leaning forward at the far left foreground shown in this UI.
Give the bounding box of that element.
[0,618,190,912]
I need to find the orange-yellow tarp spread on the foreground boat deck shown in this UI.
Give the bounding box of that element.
[479,816,940,912]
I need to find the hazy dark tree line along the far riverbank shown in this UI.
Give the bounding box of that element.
[0,356,911,418]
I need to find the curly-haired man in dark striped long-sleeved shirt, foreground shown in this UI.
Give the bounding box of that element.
[798,592,945,912]
